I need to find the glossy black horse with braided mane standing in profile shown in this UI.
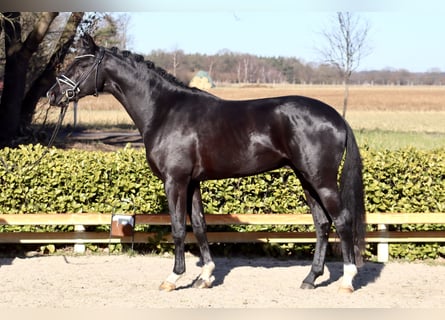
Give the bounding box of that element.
[48,35,365,292]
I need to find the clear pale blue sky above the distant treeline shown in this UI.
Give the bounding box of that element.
[119,0,445,72]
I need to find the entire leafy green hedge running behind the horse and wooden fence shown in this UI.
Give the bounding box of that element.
[0,145,445,256]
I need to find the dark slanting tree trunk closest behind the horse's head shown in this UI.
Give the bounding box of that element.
[20,12,84,128]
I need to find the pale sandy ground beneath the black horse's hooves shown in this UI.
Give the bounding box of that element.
[0,255,445,310]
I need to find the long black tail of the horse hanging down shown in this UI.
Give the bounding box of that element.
[340,122,366,266]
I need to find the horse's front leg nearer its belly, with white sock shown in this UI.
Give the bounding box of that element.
[189,182,215,289]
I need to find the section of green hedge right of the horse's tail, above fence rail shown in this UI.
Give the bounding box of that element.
[362,149,445,212]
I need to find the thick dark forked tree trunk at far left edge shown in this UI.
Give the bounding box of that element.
[0,12,58,147]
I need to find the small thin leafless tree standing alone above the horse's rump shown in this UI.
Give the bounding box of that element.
[320,12,369,117]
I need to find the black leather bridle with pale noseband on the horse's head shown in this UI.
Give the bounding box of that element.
[47,47,105,105]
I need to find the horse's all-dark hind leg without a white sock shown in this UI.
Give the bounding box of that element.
[301,183,331,289]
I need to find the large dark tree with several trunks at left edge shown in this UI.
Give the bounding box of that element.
[0,12,83,148]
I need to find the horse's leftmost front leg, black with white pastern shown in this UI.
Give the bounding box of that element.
[159,179,187,291]
